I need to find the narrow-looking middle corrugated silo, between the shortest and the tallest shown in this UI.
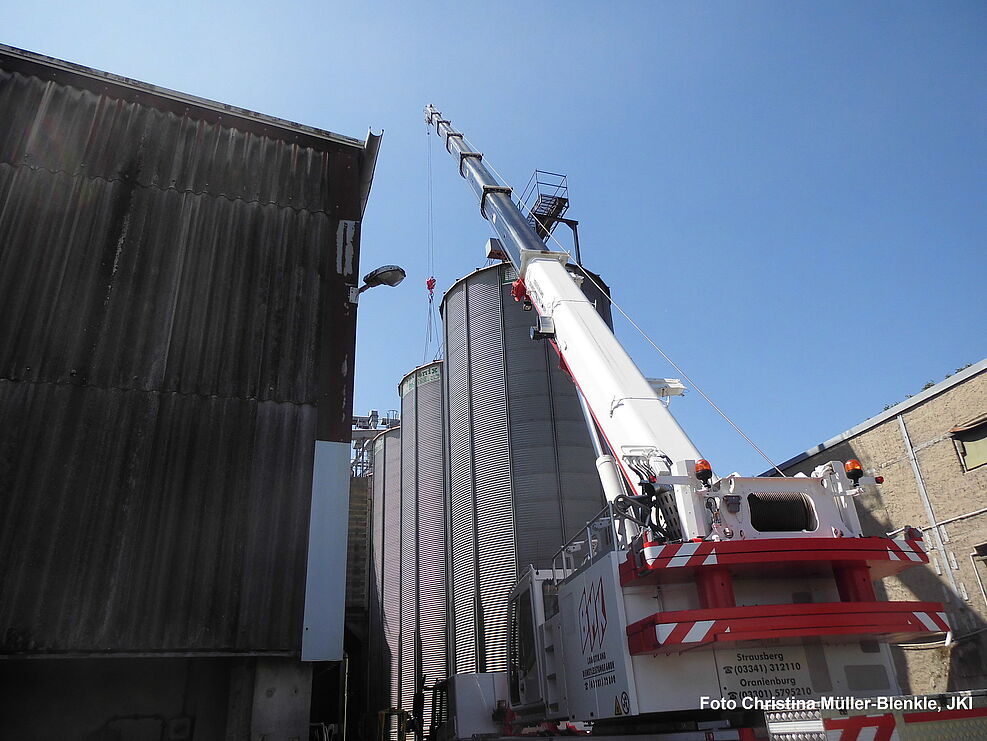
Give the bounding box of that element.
[398,361,448,722]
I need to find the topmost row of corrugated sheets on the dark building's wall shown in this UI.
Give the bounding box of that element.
[0,72,350,211]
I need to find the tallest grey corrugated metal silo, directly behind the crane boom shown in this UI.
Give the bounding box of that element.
[443,265,610,673]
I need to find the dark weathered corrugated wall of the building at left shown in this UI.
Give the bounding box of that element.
[0,51,365,655]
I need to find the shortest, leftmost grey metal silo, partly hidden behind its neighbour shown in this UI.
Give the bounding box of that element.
[369,427,401,710]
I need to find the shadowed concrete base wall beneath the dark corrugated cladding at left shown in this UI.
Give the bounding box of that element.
[0,657,312,741]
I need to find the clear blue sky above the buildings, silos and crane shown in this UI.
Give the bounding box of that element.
[0,0,987,473]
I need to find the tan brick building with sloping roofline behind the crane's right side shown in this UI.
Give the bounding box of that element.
[780,359,987,694]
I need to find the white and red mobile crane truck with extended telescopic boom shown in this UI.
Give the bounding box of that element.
[425,105,987,741]
